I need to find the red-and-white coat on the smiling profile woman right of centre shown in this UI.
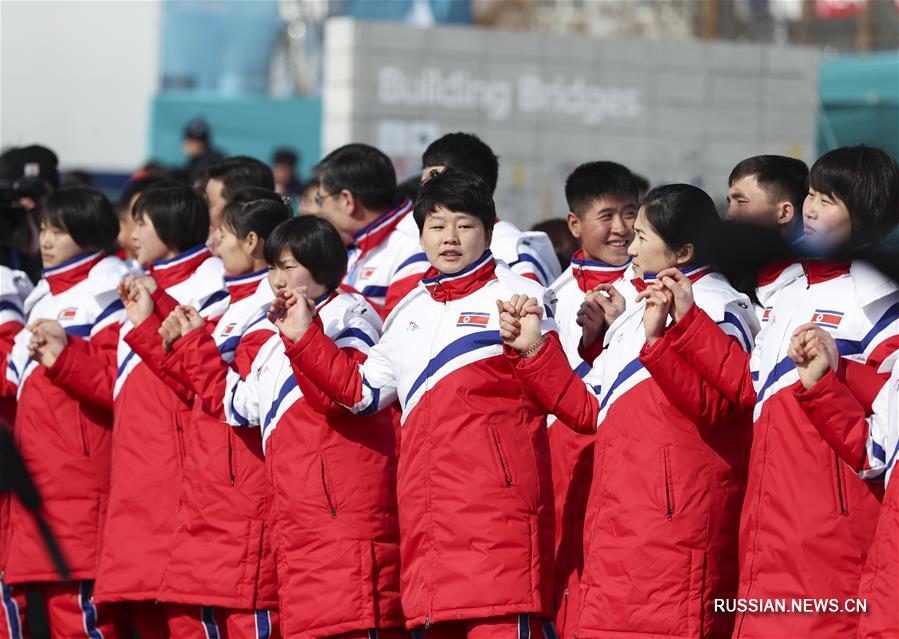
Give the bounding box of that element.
[511,276,754,638]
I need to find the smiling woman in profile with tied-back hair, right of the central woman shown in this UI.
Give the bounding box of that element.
[501,184,758,638]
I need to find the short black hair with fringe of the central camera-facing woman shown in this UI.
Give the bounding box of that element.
[412,168,496,233]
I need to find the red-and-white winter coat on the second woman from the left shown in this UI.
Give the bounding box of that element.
[51,247,227,601]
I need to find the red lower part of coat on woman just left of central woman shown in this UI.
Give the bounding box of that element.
[274,302,404,639]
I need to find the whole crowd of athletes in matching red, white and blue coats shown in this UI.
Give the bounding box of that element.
[0,129,899,639]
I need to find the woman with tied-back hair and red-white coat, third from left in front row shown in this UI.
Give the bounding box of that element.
[125,188,290,639]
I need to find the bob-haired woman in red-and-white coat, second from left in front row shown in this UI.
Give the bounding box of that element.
[34,183,228,639]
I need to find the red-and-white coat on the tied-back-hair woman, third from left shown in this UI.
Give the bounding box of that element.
[140,274,278,610]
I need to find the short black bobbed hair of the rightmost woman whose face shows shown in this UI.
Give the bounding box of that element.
[808,144,899,247]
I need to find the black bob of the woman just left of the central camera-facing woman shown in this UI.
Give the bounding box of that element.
[263,215,347,291]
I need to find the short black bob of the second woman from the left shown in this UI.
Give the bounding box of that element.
[132,182,209,253]
